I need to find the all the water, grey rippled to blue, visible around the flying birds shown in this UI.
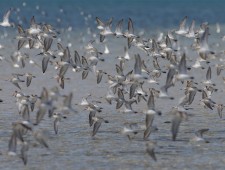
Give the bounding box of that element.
[0,1,225,170]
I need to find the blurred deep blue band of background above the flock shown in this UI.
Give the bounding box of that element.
[0,0,222,31]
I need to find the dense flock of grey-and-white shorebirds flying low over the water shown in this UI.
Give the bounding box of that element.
[0,5,225,165]
